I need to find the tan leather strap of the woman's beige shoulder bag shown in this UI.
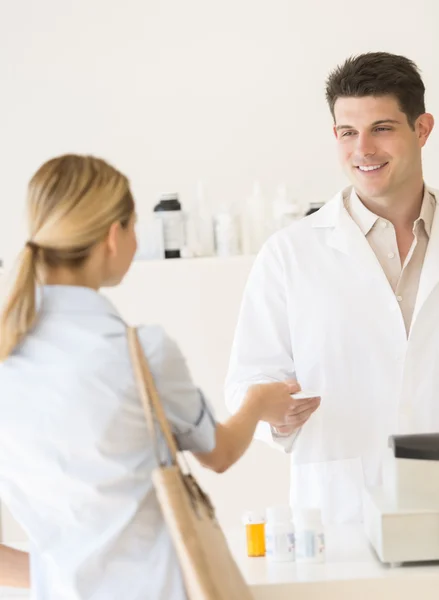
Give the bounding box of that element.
[128,327,178,464]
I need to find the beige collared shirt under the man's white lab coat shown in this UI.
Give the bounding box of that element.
[345,187,436,335]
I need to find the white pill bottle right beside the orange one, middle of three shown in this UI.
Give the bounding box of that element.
[265,506,296,562]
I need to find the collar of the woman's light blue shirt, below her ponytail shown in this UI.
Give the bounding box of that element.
[37,285,119,317]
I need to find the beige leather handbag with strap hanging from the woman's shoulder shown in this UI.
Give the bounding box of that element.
[128,328,253,600]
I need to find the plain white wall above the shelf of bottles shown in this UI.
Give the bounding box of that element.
[0,0,439,260]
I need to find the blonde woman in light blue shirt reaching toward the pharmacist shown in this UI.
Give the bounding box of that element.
[0,156,317,600]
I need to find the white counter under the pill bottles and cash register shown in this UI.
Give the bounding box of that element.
[0,527,439,600]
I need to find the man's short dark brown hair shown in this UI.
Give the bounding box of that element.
[326,52,425,127]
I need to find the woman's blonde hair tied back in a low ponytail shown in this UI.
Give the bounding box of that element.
[0,154,134,360]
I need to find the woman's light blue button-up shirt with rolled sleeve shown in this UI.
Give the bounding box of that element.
[0,286,215,600]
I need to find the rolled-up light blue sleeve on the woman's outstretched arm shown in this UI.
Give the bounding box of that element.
[139,327,216,452]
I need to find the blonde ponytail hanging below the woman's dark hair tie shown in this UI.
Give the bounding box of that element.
[0,244,36,361]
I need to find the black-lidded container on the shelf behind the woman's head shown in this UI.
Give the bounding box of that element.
[154,193,185,258]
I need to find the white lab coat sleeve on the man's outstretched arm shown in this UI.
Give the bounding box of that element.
[225,236,299,452]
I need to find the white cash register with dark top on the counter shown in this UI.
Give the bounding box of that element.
[363,433,439,565]
